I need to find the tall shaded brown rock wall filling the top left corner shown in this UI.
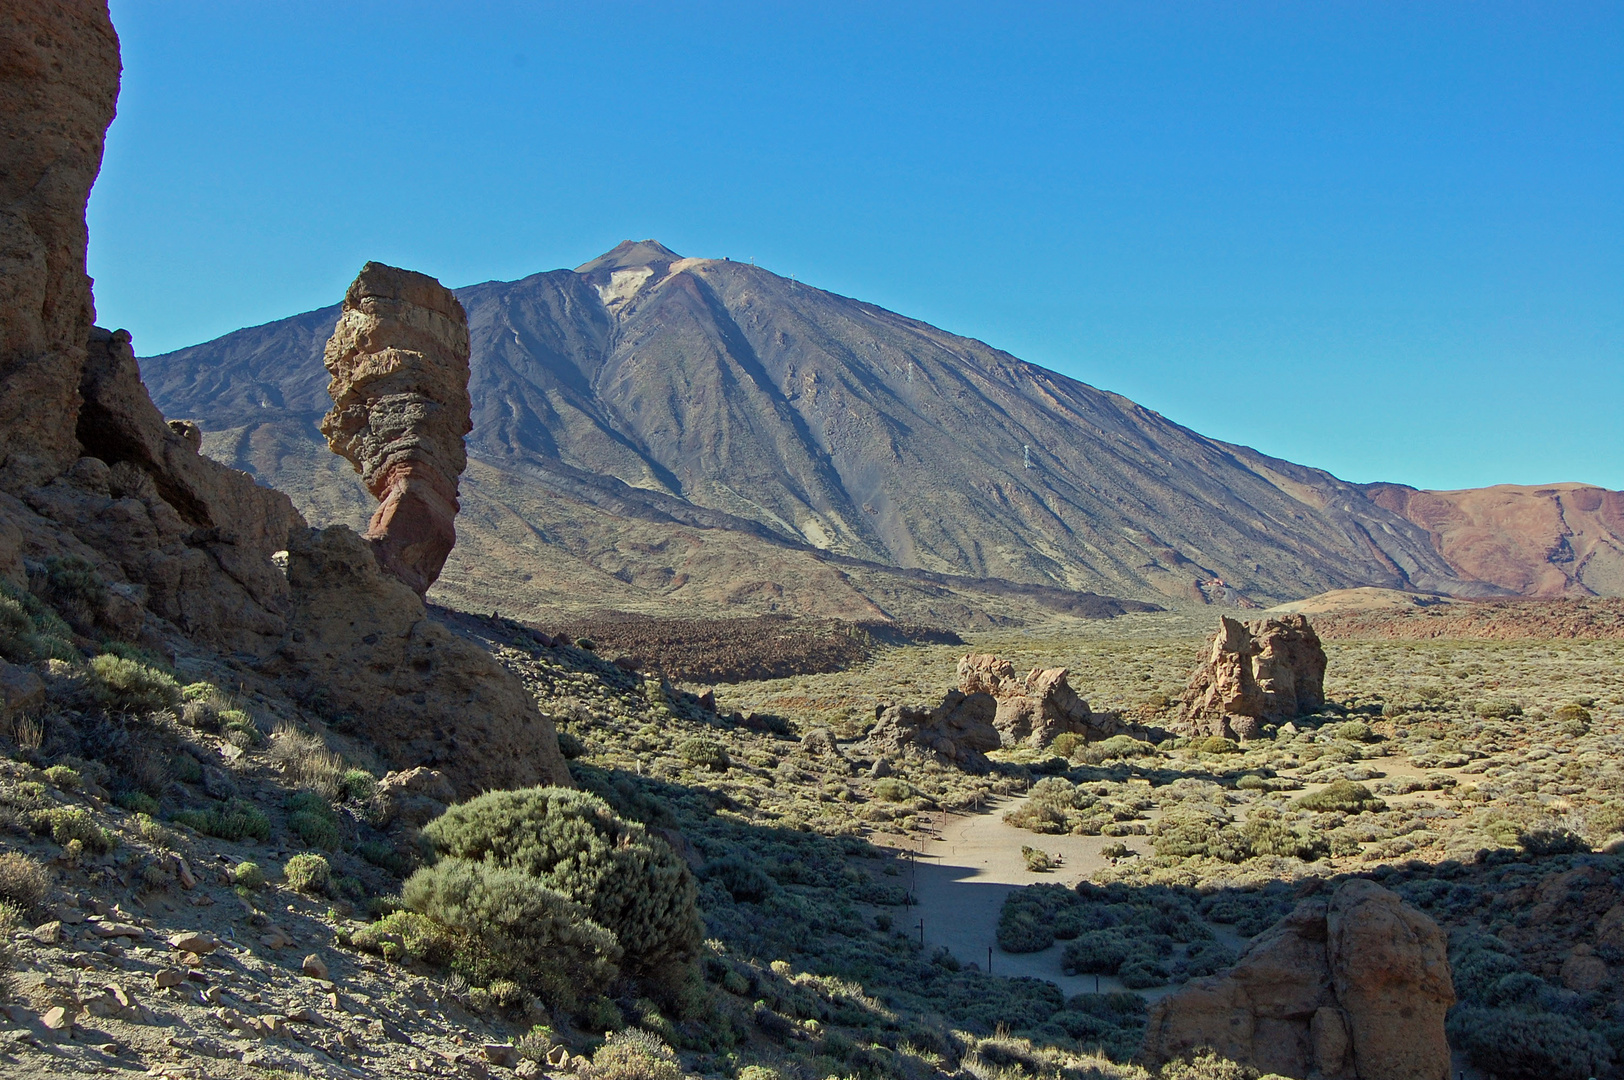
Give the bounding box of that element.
[0,0,120,494]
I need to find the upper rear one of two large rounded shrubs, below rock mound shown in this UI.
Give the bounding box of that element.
[422,788,700,981]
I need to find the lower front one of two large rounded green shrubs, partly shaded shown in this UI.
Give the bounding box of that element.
[401,858,620,1007]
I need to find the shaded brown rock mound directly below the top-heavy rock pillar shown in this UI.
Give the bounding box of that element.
[279,525,572,797]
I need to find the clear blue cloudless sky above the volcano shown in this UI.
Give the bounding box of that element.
[91,0,1624,487]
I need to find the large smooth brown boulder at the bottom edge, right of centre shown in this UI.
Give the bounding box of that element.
[1140,880,1455,1080]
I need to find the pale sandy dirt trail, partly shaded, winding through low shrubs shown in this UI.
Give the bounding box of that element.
[908,799,1171,997]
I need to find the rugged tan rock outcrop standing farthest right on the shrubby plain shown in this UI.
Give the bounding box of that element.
[1179,614,1325,739]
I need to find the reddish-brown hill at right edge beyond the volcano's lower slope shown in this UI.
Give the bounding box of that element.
[1364,484,1624,596]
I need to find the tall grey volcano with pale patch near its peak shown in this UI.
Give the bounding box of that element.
[143,240,1624,601]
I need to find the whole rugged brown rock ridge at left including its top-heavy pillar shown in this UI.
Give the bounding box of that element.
[0,3,570,794]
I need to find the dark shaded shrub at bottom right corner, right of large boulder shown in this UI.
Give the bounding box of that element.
[1449,1005,1613,1080]
